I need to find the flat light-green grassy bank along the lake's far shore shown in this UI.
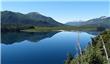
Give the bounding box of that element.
[22,26,96,32]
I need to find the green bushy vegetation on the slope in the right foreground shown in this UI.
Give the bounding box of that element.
[65,30,110,64]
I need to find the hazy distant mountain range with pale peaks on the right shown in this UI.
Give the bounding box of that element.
[66,16,110,28]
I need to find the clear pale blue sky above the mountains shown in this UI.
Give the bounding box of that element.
[1,0,110,23]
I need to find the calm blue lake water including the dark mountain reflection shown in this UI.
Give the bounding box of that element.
[1,31,96,64]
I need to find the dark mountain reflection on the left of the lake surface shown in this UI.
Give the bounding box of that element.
[1,32,58,44]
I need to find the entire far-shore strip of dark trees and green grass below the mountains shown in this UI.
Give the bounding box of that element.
[1,24,105,32]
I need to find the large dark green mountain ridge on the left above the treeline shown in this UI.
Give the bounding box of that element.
[1,11,63,26]
